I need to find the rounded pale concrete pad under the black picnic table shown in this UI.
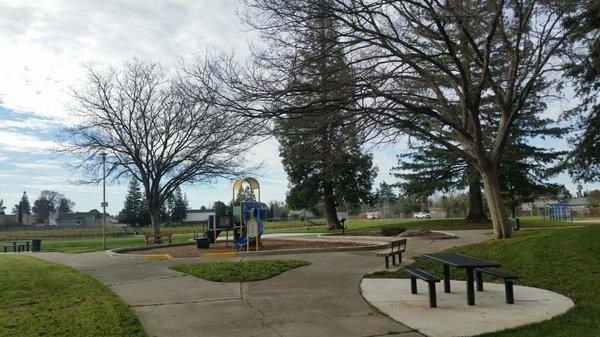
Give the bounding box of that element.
[361,278,575,337]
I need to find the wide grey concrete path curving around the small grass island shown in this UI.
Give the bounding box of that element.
[34,230,491,337]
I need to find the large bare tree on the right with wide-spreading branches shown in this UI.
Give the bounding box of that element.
[224,0,585,238]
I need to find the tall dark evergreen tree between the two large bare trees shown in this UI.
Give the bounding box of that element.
[274,3,376,229]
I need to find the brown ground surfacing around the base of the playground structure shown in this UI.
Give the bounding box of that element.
[125,239,372,257]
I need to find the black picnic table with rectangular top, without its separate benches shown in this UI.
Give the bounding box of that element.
[423,253,500,305]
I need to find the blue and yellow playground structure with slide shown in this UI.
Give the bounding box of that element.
[195,177,268,250]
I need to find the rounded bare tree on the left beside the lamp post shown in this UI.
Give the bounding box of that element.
[62,60,262,243]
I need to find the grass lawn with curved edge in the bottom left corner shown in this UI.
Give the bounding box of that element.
[0,255,146,337]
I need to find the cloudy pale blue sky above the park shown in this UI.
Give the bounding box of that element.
[0,0,599,213]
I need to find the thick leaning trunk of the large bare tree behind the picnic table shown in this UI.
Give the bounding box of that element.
[481,168,512,239]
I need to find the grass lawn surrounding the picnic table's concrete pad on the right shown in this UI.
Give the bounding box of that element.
[368,226,600,337]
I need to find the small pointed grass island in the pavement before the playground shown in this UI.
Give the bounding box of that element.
[171,260,310,282]
